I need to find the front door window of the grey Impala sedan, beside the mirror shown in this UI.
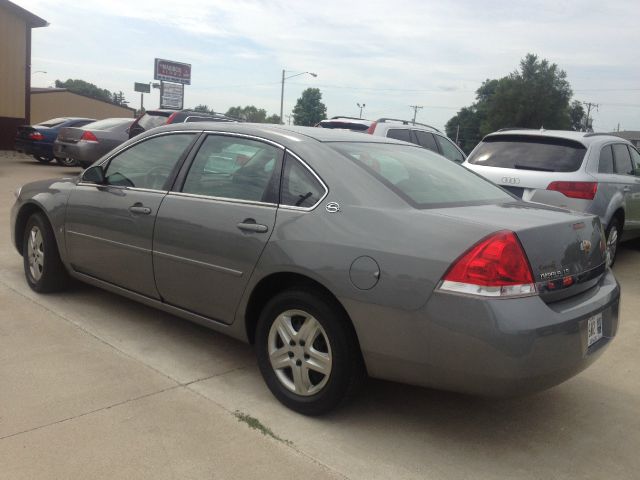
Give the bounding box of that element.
[105,133,195,190]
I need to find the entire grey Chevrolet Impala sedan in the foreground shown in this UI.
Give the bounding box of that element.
[10,123,620,415]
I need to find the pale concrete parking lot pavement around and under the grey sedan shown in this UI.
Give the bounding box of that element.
[0,152,640,479]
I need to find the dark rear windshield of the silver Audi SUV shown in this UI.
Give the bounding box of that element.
[468,135,587,172]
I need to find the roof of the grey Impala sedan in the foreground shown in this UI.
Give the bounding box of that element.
[147,121,416,147]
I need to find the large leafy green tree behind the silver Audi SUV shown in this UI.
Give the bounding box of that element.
[445,53,584,153]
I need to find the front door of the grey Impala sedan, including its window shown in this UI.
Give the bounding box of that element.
[65,133,197,298]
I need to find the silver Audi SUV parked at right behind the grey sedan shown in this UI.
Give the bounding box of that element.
[464,129,640,265]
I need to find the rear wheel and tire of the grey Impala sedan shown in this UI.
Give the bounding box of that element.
[256,289,366,415]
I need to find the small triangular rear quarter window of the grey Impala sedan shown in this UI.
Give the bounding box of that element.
[280,154,325,208]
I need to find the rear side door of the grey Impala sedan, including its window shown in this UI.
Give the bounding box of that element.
[153,134,283,323]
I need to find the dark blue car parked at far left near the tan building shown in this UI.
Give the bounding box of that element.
[14,117,95,166]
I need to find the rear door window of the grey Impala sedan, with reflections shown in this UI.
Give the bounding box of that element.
[182,135,282,203]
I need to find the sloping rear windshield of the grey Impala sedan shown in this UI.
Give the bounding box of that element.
[328,142,513,208]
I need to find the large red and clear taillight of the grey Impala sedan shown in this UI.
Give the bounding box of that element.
[440,230,536,297]
